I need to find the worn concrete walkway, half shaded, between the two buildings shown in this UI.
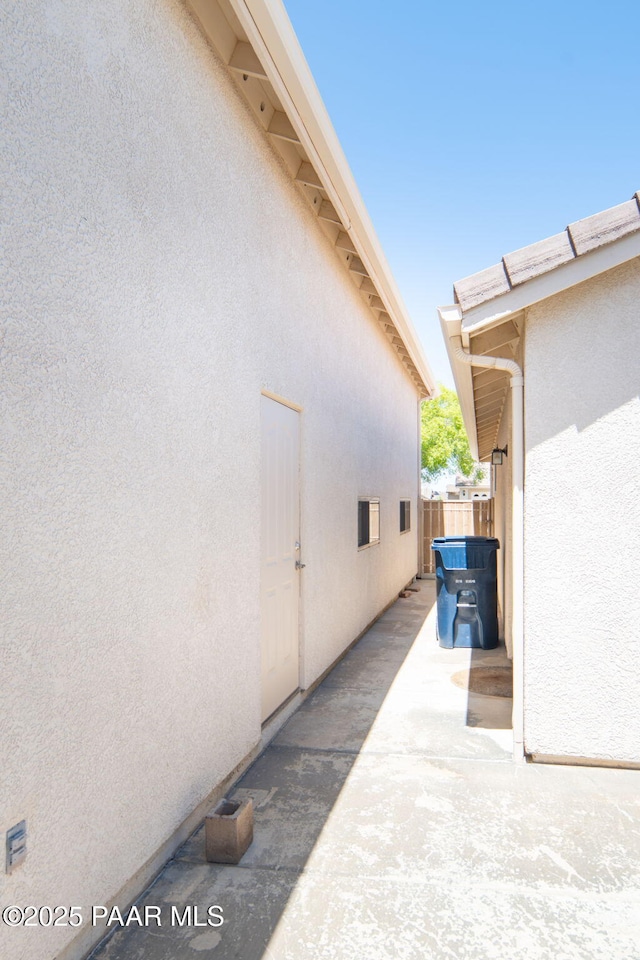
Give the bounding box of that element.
[95,581,640,960]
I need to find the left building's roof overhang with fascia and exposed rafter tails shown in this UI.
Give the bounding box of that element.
[186,0,436,396]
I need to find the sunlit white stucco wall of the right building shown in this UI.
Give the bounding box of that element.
[524,261,640,763]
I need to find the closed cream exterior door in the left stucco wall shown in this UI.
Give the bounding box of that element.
[261,397,300,720]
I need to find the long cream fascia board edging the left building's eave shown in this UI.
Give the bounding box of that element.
[228,0,436,396]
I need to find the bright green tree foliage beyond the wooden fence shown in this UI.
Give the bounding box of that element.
[422,383,482,480]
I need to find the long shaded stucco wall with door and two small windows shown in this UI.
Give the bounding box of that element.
[0,0,418,960]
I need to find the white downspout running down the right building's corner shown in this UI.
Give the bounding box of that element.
[450,336,524,760]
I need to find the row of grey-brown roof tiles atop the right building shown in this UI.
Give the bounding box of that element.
[453,191,640,310]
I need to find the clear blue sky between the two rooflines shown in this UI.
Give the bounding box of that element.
[284,0,640,385]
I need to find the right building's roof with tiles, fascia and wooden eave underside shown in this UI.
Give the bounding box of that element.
[438,191,640,460]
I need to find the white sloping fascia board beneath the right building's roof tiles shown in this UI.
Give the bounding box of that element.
[461,232,640,342]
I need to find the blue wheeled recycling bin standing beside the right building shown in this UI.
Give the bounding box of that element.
[431,537,500,650]
